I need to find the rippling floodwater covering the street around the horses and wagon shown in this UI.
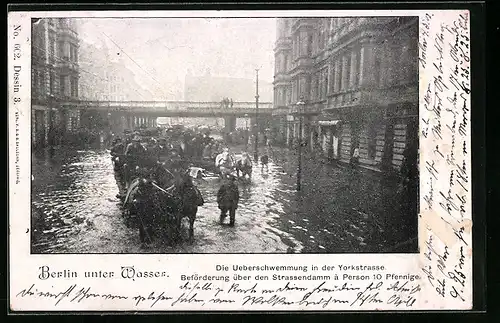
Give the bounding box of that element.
[32,148,417,253]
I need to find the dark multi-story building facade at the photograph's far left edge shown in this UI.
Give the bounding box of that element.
[31,18,80,146]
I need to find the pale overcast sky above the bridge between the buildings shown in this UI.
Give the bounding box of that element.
[78,18,276,98]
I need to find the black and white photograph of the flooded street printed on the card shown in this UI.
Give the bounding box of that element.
[31,16,420,254]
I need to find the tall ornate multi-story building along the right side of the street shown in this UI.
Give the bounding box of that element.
[274,17,418,175]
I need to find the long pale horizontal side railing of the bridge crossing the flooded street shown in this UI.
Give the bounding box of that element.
[72,101,273,111]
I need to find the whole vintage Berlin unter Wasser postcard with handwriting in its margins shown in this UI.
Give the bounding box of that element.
[7,6,473,312]
